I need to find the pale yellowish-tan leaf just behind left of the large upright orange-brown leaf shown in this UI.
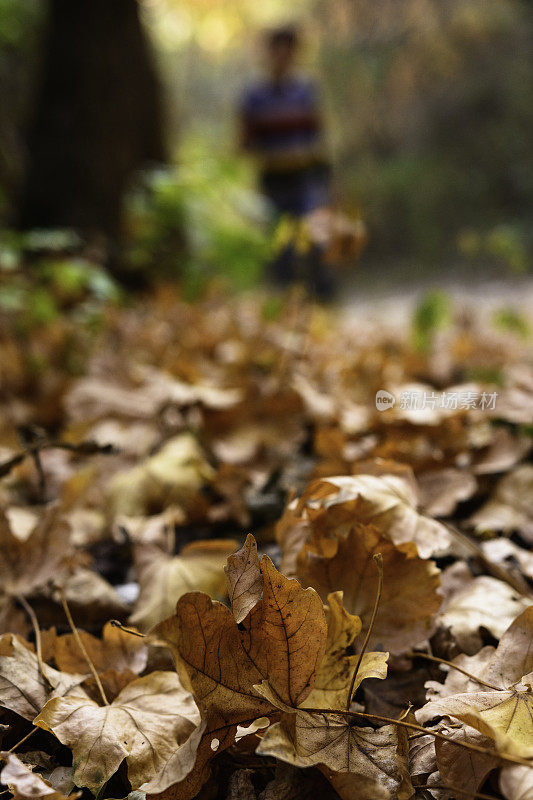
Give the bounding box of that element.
[130,539,237,631]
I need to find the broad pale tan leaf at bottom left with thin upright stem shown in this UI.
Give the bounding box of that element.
[34,672,203,794]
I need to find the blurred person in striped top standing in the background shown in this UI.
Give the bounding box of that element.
[240,26,334,299]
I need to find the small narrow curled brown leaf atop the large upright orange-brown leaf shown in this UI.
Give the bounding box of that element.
[224,534,263,622]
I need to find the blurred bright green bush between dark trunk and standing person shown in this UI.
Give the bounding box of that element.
[126,138,271,296]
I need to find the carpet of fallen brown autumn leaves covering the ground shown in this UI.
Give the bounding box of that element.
[0,290,533,800]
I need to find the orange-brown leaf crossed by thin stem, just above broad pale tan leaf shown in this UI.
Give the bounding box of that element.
[54,622,148,674]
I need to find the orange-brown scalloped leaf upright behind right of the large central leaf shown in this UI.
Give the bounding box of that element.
[296,523,441,653]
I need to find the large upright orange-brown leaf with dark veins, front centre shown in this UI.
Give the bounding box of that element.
[150,542,327,797]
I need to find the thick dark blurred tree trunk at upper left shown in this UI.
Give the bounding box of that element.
[19,0,165,238]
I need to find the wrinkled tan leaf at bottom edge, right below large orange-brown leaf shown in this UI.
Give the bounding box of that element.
[256,709,399,798]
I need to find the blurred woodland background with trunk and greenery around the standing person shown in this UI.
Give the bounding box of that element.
[0,0,533,304]
